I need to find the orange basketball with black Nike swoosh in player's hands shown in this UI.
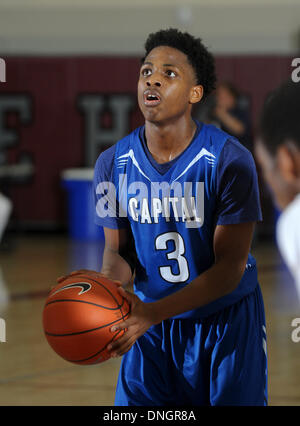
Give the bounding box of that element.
[43,273,130,365]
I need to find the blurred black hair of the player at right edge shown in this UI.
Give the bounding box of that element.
[259,80,300,155]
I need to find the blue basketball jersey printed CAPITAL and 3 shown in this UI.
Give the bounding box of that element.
[94,123,260,318]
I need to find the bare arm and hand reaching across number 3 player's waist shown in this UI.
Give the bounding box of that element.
[110,222,255,356]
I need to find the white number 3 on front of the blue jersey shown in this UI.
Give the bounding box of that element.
[155,232,190,283]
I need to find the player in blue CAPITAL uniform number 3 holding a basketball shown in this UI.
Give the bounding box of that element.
[71,29,267,406]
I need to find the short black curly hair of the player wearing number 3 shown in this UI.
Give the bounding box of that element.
[142,28,217,97]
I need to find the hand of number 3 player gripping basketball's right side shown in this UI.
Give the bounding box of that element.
[107,287,156,357]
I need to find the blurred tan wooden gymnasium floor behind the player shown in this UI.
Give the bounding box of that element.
[0,235,300,406]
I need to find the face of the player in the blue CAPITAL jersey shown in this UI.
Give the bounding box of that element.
[138,46,203,123]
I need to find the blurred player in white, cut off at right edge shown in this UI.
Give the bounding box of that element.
[255,81,300,298]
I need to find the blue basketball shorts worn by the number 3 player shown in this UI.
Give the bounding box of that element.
[115,285,267,406]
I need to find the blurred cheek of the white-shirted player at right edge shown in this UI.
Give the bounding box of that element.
[255,140,293,209]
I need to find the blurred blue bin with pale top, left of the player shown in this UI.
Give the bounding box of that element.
[61,168,104,241]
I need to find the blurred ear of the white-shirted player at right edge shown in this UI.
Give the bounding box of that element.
[277,142,300,183]
